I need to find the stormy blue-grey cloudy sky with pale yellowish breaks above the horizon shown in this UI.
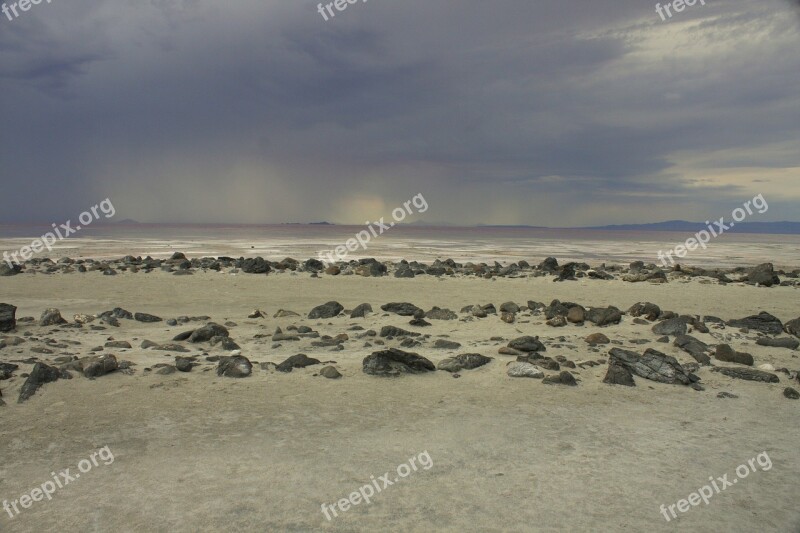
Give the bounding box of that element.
[0,0,800,227]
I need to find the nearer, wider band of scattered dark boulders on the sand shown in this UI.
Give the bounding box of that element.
[0,294,800,402]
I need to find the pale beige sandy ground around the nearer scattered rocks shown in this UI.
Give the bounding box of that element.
[0,272,800,533]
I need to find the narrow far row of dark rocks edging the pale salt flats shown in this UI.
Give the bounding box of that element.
[0,252,800,287]
